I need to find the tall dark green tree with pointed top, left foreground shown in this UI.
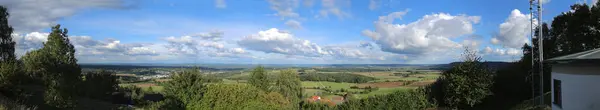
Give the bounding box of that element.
[22,25,81,108]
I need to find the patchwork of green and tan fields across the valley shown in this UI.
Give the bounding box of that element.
[91,64,441,105]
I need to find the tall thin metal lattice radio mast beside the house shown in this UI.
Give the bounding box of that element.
[529,0,544,105]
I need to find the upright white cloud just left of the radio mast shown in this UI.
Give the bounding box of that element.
[491,9,531,48]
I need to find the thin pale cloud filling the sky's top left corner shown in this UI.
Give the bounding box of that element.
[0,0,135,33]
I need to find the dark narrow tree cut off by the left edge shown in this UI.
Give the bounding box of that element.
[0,6,16,63]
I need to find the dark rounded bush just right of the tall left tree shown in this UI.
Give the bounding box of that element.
[82,70,119,100]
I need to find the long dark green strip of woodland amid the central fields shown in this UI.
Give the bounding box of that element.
[300,72,376,83]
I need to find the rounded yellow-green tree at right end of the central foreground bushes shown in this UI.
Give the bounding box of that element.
[272,69,302,108]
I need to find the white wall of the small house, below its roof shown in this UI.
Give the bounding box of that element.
[551,72,600,110]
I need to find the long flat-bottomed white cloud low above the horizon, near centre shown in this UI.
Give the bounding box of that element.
[237,28,405,63]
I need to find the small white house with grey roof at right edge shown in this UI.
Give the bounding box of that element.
[548,48,600,110]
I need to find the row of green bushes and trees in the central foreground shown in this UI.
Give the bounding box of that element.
[141,67,302,110]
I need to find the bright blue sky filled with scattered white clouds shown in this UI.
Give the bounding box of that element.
[0,0,595,64]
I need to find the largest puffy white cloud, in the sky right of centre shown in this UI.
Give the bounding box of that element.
[363,10,480,55]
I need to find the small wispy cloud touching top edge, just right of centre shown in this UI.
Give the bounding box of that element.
[318,0,350,18]
